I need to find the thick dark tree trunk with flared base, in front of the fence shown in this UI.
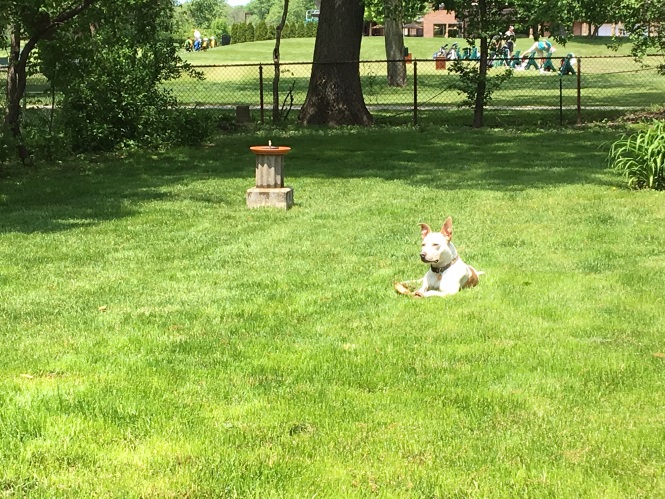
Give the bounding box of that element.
[298,0,372,125]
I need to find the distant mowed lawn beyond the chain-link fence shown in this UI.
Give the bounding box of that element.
[166,37,665,120]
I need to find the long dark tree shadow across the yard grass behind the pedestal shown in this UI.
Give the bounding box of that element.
[0,126,616,233]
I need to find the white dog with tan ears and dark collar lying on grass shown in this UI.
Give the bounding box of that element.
[413,217,484,296]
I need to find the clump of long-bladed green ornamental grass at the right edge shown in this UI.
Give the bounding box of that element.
[608,120,665,190]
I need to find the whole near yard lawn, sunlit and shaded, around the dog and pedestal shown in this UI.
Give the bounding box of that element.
[0,128,665,498]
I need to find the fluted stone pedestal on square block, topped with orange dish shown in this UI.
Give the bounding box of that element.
[247,146,293,210]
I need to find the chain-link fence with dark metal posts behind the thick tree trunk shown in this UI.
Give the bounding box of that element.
[9,55,665,126]
